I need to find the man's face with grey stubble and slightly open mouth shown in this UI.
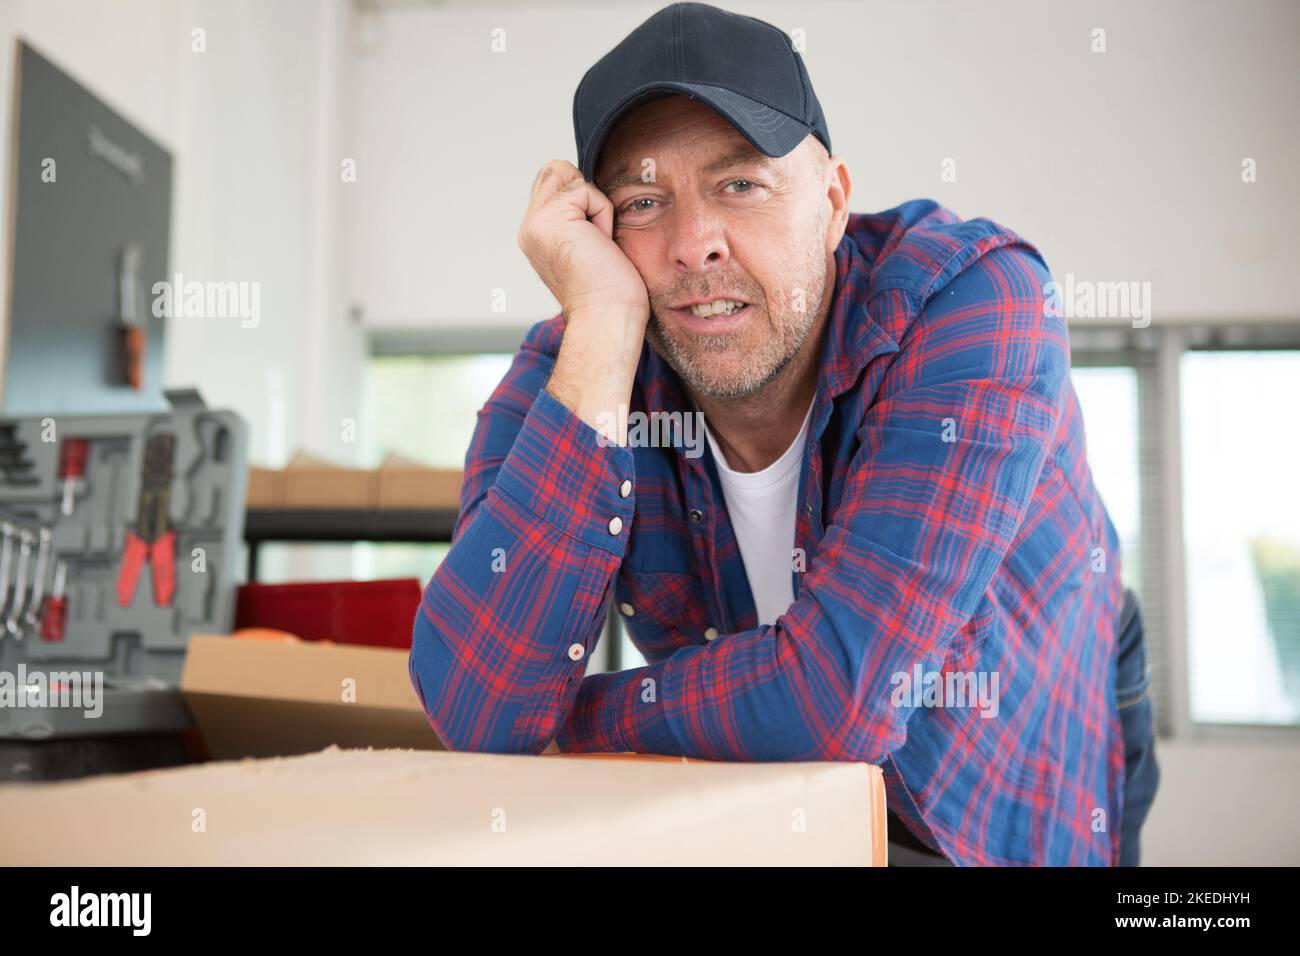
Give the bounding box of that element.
[595,96,842,399]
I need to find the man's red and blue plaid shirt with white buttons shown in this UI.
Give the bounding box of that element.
[411,200,1123,865]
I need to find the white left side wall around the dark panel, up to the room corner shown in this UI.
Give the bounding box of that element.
[0,0,364,464]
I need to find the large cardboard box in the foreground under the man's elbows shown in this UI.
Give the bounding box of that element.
[0,748,885,866]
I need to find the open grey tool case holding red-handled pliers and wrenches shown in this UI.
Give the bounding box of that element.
[0,390,247,754]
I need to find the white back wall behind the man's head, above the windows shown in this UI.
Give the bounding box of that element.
[347,0,1300,328]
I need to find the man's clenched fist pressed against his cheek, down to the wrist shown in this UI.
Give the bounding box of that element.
[517,160,650,317]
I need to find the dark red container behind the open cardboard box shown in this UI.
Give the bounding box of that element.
[235,578,421,648]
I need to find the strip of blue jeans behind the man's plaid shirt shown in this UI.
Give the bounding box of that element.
[1115,589,1160,866]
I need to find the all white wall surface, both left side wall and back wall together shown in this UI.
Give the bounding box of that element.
[0,0,1300,442]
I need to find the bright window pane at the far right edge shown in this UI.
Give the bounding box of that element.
[1182,351,1300,723]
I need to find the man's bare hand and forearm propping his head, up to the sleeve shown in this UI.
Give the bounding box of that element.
[517,160,650,444]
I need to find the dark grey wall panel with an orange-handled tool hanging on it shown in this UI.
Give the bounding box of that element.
[3,43,172,415]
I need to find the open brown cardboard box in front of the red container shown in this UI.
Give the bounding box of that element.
[181,635,442,760]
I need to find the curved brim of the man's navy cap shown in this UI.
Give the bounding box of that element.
[579,81,813,181]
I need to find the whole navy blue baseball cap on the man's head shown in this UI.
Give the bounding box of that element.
[573,4,831,181]
